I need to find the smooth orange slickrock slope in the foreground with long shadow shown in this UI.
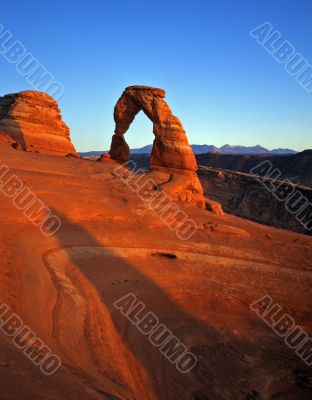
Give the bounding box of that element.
[0,144,312,400]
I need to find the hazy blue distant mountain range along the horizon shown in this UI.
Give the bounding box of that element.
[79,144,297,157]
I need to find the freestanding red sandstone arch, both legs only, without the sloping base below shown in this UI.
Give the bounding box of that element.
[110,86,197,171]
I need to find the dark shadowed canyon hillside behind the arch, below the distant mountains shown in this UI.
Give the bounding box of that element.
[131,150,312,234]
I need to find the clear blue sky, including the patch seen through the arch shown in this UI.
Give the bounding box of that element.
[0,0,312,151]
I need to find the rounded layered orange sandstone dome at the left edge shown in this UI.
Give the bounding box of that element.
[0,90,77,156]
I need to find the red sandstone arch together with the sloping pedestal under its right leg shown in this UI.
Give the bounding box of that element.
[108,86,216,209]
